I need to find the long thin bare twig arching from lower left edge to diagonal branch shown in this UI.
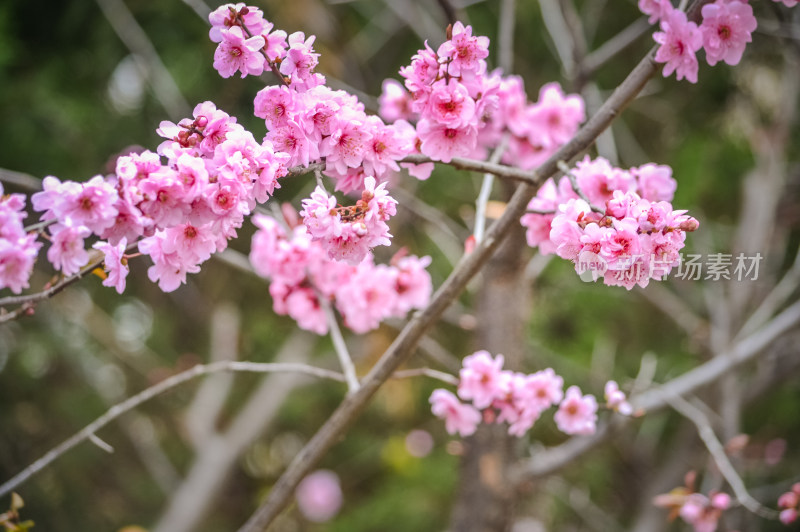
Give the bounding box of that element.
[0,360,345,497]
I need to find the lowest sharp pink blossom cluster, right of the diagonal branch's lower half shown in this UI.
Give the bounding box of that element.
[430,351,632,436]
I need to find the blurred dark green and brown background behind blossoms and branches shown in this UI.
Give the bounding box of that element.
[0,0,800,532]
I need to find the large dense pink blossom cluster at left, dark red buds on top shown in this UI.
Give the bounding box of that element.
[32,102,288,293]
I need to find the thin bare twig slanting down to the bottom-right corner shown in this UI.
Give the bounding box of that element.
[666,395,778,519]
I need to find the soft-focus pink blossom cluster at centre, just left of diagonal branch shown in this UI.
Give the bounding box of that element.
[250,213,432,334]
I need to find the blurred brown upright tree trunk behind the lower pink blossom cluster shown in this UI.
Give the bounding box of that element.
[450,192,529,532]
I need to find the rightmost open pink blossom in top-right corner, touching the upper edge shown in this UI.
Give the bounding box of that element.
[700,0,757,66]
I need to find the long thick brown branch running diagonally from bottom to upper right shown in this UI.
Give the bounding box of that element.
[240,40,657,532]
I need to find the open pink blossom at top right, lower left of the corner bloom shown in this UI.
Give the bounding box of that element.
[653,9,703,83]
